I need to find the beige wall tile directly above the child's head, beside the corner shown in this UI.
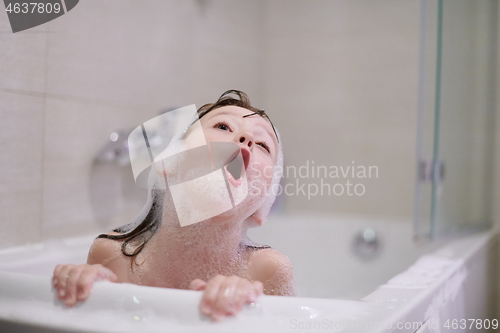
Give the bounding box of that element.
[193,1,265,106]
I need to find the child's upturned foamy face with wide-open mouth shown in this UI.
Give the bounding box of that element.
[156,106,279,226]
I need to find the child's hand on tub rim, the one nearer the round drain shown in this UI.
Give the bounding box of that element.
[189,275,263,321]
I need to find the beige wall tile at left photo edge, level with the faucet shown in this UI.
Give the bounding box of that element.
[0,91,44,247]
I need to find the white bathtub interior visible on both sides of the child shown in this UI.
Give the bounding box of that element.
[0,213,438,300]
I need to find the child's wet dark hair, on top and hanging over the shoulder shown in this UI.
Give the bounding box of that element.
[96,90,278,265]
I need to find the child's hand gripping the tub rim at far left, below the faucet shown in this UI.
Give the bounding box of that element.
[52,264,118,306]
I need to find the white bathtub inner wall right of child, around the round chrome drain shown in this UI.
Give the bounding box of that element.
[248,213,439,300]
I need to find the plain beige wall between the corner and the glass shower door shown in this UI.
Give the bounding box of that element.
[265,0,420,217]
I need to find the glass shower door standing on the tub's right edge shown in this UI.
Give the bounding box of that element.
[415,0,497,237]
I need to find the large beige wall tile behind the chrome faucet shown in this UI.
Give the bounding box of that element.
[43,99,157,239]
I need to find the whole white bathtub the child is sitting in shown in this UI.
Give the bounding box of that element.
[0,214,498,333]
